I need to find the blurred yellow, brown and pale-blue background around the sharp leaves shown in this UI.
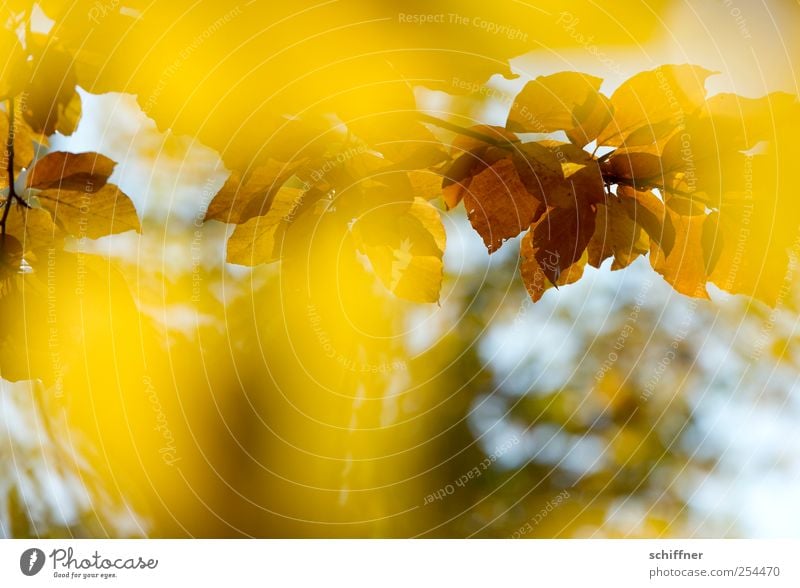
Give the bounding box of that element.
[0,0,800,538]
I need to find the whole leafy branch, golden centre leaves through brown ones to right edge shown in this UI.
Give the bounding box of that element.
[207,65,800,304]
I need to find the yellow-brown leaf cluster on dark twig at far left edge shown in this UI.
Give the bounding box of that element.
[0,13,140,283]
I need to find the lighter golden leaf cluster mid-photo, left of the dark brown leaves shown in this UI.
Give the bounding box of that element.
[206,133,445,302]
